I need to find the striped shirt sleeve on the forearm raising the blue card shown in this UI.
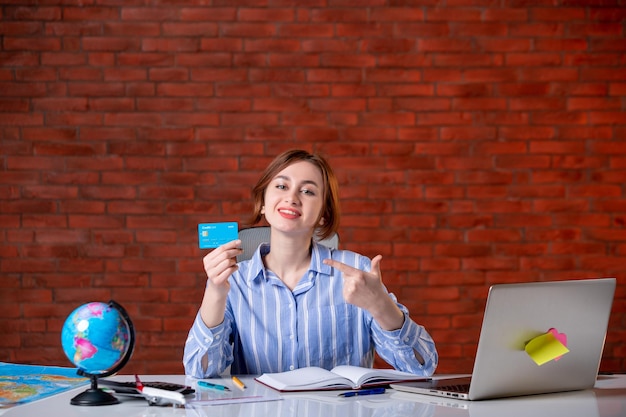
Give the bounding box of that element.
[183,312,233,378]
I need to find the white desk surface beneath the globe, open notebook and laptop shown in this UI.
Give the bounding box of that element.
[2,375,626,417]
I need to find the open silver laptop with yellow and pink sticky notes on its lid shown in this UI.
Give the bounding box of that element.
[391,278,616,400]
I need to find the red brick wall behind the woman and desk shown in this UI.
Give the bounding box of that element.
[0,0,626,373]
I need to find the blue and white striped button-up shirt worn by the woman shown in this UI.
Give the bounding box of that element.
[183,243,438,378]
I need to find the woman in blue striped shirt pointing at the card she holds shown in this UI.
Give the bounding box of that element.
[183,150,438,378]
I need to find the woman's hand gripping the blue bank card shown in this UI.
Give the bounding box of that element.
[202,239,243,296]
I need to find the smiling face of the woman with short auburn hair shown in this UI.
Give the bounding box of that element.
[263,161,324,234]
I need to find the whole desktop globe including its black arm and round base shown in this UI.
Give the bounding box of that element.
[61,300,135,405]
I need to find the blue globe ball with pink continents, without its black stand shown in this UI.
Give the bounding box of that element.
[61,302,131,375]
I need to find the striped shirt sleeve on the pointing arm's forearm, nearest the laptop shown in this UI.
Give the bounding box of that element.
[372,294,439,376]
